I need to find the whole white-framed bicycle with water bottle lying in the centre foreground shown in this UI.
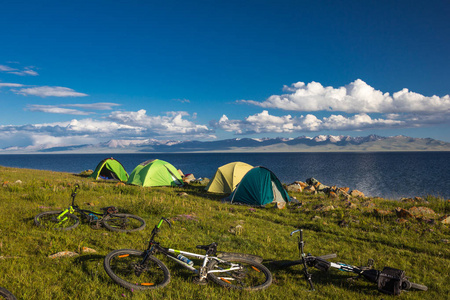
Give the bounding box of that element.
[103,217,272,290]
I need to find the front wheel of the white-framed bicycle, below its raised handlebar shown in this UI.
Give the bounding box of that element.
[103,249,170,290]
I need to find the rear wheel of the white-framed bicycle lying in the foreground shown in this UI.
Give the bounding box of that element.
[207,256,272,291]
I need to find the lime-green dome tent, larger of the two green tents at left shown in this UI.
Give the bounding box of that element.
[127,159,183,186]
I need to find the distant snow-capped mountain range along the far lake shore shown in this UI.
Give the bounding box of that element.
[0,135,450,154]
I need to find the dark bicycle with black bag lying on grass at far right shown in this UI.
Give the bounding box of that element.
[284,229,428,295]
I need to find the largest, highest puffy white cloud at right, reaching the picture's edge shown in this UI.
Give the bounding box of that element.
[238,79,450,113]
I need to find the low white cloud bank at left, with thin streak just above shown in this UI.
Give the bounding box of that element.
[0,109,215,147]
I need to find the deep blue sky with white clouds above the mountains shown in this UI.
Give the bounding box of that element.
[0,0,450,148]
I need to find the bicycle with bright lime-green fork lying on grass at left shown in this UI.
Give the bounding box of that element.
[34,184,145,232]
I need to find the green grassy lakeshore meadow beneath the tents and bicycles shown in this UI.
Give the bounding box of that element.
[0,167,450,299]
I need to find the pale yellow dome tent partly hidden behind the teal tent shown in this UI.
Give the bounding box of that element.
[205,161,253,194]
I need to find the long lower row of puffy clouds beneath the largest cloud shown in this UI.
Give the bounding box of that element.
[212,110,408,134]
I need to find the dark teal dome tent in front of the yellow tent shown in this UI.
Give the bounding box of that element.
[230,167,290,206]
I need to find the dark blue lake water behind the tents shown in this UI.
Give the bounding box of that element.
[0,152,450,199]
